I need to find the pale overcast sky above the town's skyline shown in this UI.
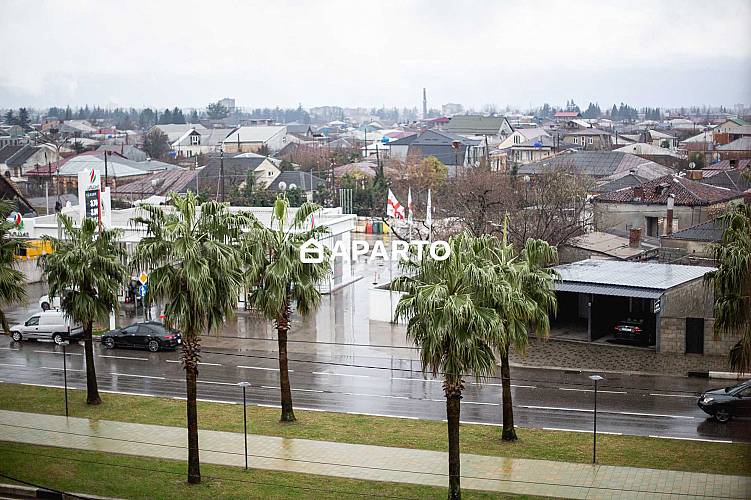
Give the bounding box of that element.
[0,0,751,108]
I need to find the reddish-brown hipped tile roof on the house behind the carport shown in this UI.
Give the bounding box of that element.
[595,175,741,206]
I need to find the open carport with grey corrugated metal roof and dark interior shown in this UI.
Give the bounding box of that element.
[551,259,711,351]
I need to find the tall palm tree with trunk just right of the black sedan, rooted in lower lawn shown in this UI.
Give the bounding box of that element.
[131,192,247,483]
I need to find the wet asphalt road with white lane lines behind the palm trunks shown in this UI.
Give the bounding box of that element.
[0,337,751,442]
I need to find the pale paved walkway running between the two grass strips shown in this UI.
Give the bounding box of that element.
[0,410,751,499]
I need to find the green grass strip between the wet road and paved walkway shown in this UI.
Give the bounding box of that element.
[0,384,751,475]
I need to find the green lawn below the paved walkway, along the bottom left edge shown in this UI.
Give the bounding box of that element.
[0,441,530,499]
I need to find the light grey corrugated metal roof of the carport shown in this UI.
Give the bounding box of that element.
[554,259,714,299]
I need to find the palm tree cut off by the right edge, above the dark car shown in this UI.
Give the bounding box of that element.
[705,203,751,373]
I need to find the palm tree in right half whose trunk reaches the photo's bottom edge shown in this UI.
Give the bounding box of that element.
[392,233,500,499]
